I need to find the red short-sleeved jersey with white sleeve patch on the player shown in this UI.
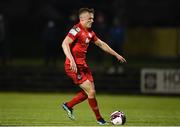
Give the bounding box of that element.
[65,23,98,67]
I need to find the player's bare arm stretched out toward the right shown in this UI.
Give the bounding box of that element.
[95,39,126,63]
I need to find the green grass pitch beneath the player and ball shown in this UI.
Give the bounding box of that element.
[0,92,180,126]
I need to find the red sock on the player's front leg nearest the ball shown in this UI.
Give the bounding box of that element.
[88,98,102,120]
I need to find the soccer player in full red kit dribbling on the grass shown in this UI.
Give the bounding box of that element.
[62,8,126,124]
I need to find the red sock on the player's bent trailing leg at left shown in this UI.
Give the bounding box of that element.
[66,91,87,108]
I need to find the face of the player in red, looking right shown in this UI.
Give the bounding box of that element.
[80,13,94,28]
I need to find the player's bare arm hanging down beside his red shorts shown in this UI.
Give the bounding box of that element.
[62,36,77,73]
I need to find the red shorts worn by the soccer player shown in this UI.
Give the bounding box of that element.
[65,64,93,85]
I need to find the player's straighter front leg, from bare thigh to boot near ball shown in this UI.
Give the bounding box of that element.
[80,79,106,124]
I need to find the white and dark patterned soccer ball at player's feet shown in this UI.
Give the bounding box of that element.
[110,111,126,125]
